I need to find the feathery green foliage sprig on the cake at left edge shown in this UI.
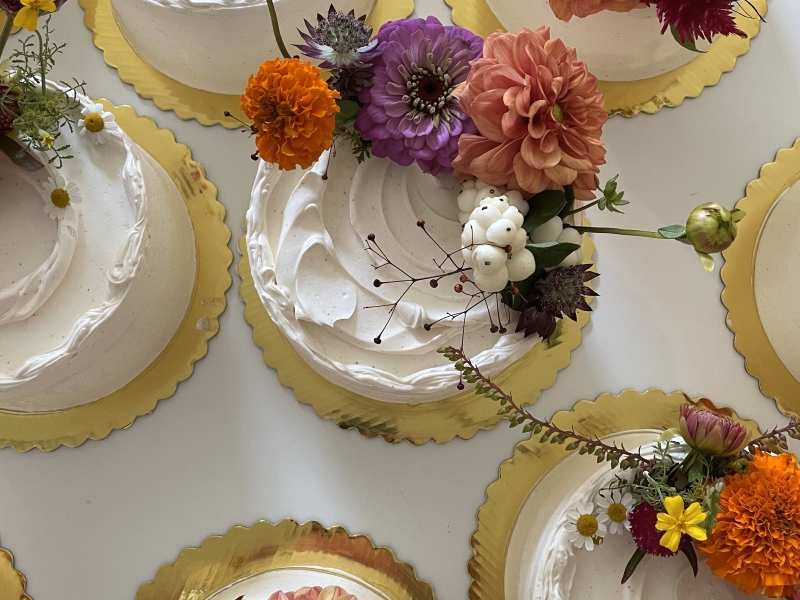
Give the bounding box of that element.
[0,17,86,168]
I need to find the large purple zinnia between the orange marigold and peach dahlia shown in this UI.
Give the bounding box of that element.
[356,17,483,175]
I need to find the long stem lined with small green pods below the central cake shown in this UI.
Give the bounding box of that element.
[439,346,653,469]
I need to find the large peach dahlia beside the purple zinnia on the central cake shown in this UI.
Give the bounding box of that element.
[453,27,608,200]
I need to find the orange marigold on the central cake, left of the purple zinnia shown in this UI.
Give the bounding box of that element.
[241,58,339,171]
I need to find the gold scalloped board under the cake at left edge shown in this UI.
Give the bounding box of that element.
[0,100,233,452]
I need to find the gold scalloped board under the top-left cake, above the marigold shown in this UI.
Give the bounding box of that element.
[79,0,414,129]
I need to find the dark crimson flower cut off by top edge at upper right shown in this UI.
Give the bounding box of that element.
[646,0,747,42]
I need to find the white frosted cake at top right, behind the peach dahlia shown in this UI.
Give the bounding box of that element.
[486,0,708,81]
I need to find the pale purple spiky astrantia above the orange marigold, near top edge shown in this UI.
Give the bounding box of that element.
[296,4,380,69]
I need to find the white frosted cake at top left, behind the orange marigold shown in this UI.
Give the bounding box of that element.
[111,0,375,94]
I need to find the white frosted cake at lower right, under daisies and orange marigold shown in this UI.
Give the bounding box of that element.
[506,431,749,600]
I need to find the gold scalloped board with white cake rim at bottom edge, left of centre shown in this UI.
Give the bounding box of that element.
[136,519,433,600]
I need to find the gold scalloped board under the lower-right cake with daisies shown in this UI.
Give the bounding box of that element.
[467,388,758,600]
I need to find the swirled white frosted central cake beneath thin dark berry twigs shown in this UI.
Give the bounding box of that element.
[246,151,538,403]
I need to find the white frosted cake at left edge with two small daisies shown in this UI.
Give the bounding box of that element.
[0,84,195,412]
